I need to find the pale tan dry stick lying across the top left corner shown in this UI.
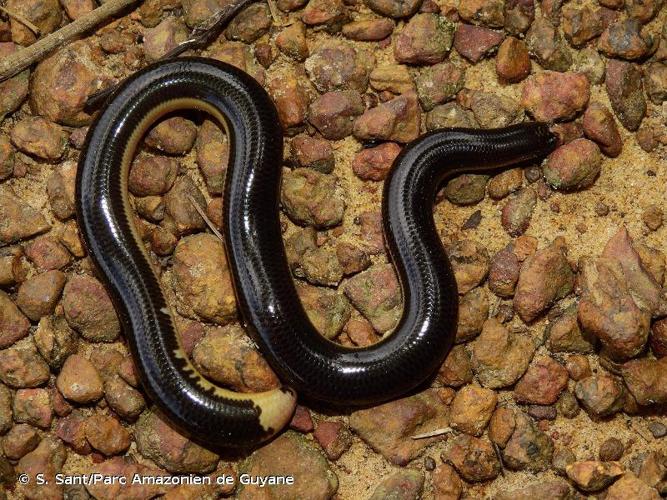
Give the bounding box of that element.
[0,0,138,82]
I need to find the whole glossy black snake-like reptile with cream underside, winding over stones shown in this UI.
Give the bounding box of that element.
[77,58,556,446]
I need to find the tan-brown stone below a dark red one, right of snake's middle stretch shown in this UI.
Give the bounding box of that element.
[281,168,345,228]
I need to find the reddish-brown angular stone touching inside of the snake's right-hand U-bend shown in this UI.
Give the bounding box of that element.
[344,264,402,333]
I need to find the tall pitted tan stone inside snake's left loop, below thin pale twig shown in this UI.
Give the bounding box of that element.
[173,233,236,325]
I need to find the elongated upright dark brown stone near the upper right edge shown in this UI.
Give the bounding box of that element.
[605,59,646,132]
